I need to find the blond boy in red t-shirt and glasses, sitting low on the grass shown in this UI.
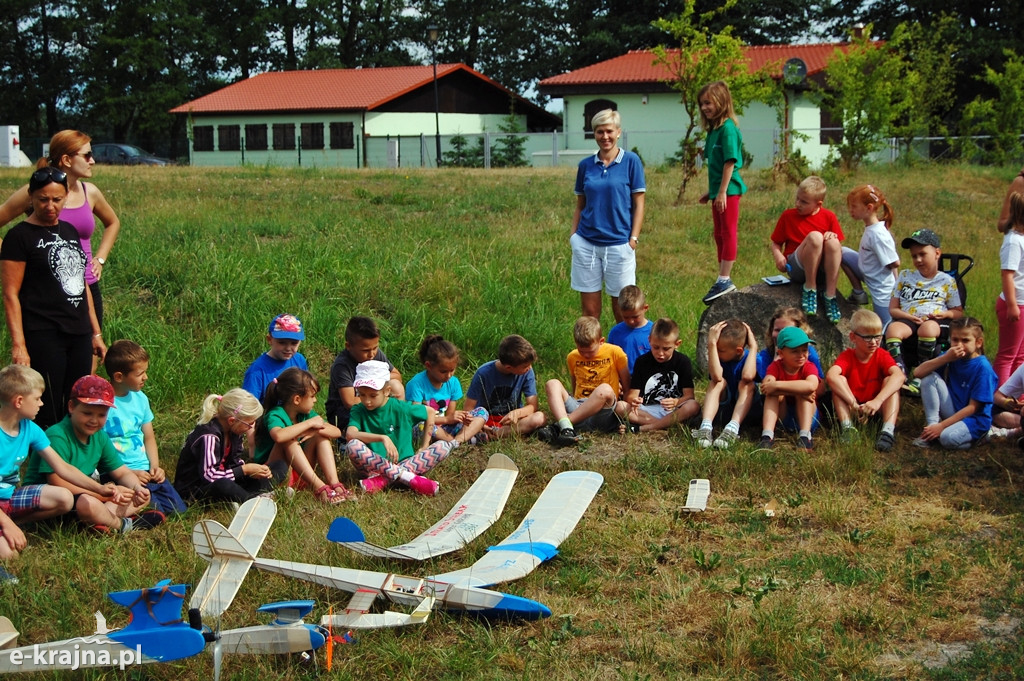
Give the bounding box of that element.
[825,309,906,452]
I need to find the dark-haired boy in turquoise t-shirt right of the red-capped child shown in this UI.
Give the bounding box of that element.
[103,340,187,515]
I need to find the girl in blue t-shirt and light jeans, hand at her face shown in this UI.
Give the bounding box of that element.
[913,316,997,450]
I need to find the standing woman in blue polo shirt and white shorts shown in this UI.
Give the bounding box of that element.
[569,109,646,322]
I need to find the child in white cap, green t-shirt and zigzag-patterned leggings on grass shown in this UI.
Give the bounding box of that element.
[345,359,459,497]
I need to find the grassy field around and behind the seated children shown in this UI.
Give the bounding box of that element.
[0,160,1024,680]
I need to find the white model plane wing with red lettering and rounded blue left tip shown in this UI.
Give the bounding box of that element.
[327,454,519,560]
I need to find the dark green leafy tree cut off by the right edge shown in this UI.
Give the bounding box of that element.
[961,50,1024,164]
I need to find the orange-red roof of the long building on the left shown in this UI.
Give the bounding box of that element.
[171,63,468,114]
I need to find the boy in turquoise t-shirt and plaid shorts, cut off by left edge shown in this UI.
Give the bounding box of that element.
[0,365,113,582]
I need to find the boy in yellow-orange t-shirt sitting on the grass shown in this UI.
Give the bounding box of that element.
[537,316,630,446]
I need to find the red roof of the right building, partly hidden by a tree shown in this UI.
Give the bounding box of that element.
[540,43,868,89]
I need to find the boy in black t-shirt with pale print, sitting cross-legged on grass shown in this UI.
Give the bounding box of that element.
[626,318,700,432]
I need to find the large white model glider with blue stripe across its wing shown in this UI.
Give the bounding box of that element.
[194,471,604,629]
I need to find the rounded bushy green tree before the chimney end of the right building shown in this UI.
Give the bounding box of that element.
[816,26,902,168]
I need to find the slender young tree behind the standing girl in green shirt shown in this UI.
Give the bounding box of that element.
[653,0,781,205]
